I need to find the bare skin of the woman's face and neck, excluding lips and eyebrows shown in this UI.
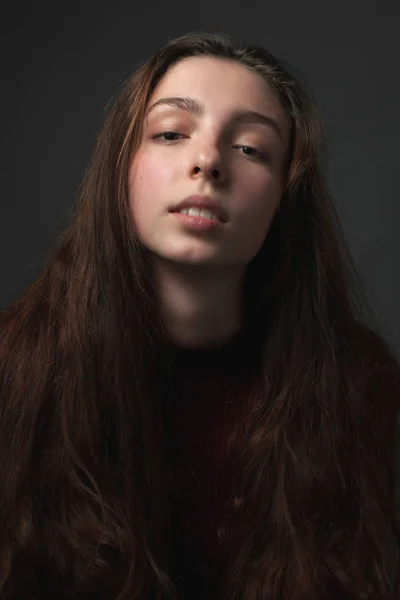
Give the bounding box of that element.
[129,57,290,344]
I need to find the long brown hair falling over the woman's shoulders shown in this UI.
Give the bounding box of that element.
[0,33,400,600]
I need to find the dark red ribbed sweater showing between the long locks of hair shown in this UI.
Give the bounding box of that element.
[161,333,261,600]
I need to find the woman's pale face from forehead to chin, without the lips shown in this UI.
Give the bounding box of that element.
[129,57,290,268]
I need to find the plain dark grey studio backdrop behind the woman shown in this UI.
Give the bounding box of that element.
[0,0,400,358]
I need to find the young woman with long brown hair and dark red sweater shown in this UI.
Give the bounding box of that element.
[0,34,400,600]
